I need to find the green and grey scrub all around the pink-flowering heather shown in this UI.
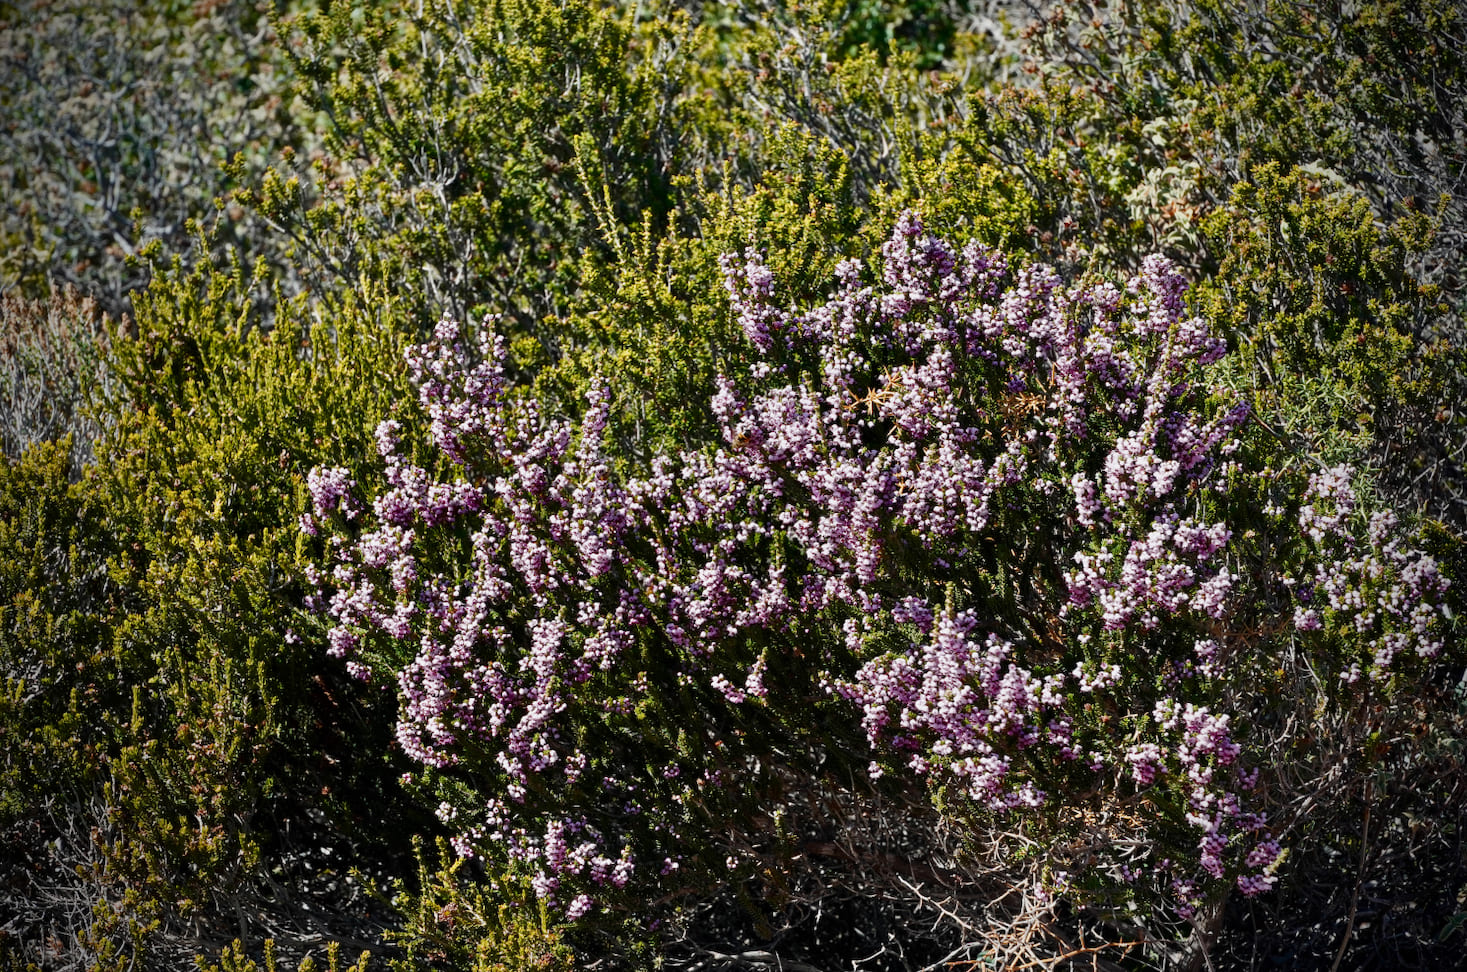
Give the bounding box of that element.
[0,0,1467,972]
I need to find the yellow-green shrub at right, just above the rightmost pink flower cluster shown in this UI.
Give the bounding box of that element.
[1196,163,1439,453]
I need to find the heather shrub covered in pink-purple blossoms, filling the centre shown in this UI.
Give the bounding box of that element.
[312,214,1445,919]
